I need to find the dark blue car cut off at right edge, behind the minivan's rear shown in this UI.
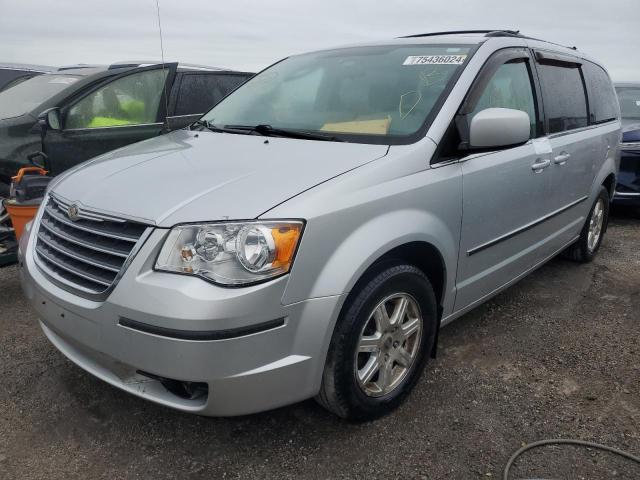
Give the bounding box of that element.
[614,82,640,207]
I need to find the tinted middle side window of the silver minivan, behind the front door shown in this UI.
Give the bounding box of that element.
[538,63,588,133]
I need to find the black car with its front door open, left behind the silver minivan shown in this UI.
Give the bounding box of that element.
[0,62,253,193]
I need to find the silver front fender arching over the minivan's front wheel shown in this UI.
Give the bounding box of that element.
[277,147,462,313]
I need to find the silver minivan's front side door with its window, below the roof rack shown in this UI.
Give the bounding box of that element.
[455,48,555,310]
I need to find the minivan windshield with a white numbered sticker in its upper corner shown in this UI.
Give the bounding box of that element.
[203,45,471,143]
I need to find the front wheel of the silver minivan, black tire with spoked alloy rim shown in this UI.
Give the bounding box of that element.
[316,263,438,420]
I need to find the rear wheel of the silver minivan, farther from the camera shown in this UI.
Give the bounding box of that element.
[565,187,609,263]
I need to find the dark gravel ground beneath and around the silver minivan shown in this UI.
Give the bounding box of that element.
[0,212,640,479]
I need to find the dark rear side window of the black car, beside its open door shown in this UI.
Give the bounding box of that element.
[175,73,248,115]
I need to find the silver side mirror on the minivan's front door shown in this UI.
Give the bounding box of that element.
[469,108,531,148]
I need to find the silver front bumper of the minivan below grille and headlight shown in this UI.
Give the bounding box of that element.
[19,223,344,416]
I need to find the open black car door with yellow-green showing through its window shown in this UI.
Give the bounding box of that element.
[43,63,177,175]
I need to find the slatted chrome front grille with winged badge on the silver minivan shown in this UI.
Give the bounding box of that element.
[36,196,147,294]
